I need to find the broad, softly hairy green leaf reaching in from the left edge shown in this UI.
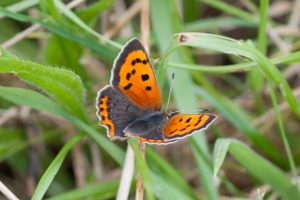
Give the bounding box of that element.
[0,49,87,120]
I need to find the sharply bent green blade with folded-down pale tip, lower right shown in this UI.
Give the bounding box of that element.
[214,139,300,199]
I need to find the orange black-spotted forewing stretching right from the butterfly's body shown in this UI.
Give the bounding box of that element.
[162,114,216,139]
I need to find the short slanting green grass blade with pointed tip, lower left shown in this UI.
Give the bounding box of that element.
[32,134,84,200]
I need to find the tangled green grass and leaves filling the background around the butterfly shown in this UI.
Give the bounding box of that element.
[0,0,300,200]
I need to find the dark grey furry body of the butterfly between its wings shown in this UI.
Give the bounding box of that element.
[124,111,168,136]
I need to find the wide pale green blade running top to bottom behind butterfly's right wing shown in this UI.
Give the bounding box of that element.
[150,0,218,200]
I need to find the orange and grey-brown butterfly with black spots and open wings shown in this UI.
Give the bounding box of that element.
[96,38,216,144]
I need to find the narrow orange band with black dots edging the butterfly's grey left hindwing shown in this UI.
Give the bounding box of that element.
[98,96,115,138]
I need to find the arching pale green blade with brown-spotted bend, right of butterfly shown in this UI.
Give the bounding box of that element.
[162,33,300,116]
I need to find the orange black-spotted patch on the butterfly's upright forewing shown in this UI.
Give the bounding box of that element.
[118,50,161,110]
